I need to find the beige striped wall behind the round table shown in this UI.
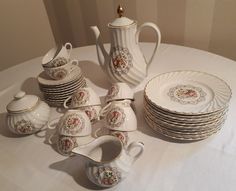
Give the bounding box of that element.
[0,0,236,70]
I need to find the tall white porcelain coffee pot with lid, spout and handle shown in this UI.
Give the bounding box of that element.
[91,6,161,86]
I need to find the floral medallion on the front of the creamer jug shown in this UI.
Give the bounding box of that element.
[94,166,121,186]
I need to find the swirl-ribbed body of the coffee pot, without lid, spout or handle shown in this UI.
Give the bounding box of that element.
[106,22,147,85]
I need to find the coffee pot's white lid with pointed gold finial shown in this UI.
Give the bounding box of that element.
[108,5,134,27]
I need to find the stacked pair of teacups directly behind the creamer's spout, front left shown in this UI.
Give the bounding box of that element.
[48,110,93,156]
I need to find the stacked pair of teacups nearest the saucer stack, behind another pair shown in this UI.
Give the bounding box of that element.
[63,87,101,124]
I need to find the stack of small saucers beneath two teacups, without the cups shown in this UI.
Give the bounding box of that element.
[37,66,86,107]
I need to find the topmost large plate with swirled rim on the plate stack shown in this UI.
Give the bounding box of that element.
[144,70,232,115]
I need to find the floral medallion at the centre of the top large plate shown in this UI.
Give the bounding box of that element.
[167,85,207,105]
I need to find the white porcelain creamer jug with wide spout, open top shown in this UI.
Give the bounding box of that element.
[72,135,144,187]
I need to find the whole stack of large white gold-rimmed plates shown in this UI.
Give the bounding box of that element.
[144,71,231,141]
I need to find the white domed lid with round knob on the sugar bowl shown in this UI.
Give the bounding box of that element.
[7,91,39,114]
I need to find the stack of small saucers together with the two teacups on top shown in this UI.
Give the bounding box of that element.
[37,43,86,106]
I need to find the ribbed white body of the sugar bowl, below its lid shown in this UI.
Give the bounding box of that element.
[7,101,50,135]
